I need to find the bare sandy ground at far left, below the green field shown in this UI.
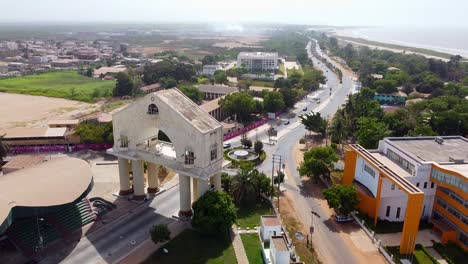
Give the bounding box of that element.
[0,93,99,129]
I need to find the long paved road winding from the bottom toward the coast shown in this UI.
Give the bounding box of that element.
[252,40,376,263]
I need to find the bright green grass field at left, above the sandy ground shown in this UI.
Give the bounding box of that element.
[0,71,115,102]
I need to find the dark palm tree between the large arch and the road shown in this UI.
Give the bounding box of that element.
[230,163,259,204]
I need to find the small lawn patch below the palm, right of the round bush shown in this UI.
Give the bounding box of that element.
[236,201,274,229]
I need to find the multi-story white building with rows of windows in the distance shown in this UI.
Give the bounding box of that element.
[237,52,278,72]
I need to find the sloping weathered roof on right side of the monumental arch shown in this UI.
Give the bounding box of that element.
[155,89,221,133]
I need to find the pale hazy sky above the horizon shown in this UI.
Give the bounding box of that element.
[0,0,468,28]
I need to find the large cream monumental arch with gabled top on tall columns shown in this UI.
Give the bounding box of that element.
[107,89,229,216]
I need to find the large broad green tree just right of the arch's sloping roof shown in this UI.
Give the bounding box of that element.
[219,92,255,122]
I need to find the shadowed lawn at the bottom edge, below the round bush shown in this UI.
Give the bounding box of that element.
[142,230,237,264]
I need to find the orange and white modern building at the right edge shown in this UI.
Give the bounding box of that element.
[343,136,468,254]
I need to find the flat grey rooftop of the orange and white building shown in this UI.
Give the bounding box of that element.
[384,136,468,163]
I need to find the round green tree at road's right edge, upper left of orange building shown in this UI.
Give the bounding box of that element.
[298,147,339,180]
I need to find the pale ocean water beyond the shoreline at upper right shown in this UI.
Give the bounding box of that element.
[345,27,468,58]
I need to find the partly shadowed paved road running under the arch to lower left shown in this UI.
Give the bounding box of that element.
[41,185,179,264]
